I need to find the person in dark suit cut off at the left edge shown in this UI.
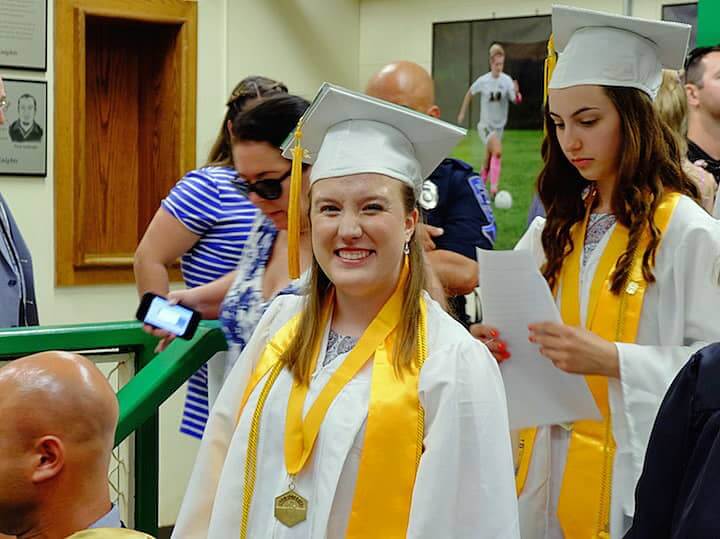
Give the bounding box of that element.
[0,78,38,328]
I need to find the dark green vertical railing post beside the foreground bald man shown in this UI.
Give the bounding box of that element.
[134,347,160,537]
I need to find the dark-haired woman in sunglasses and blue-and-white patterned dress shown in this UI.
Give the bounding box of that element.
[147,95,310,437]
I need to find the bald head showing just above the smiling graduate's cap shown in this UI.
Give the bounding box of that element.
[365,61,440,118]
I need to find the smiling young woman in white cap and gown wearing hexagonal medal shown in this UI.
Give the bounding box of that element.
[174,85,519,539]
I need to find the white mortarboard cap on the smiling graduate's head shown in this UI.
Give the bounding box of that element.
[282,83,465,196]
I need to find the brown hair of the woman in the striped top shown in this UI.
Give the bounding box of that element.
[205,75,288,167]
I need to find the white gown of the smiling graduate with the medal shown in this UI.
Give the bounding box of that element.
[173,296,519,539]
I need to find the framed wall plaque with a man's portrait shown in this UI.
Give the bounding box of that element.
[0,79,47,176]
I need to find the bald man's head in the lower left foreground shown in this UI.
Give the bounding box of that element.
[0,352,118,533]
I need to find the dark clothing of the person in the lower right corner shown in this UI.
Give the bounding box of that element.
[625,343,720,539]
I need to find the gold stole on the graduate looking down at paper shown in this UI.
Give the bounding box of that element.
[517,193,680,539]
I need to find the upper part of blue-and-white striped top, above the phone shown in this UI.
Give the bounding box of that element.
[162,167,257,288]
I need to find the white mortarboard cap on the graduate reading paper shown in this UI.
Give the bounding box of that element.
[549,6,690,99]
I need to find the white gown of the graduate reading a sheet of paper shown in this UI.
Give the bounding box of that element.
[516,196,720,539]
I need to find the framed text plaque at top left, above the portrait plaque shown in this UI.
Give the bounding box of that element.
[0,0,47,71]
